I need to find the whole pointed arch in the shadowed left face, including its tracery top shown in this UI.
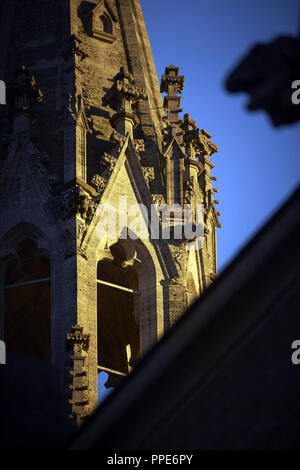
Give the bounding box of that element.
[0,222,51,360]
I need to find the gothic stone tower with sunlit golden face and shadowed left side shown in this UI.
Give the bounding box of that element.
[0,0,220,423]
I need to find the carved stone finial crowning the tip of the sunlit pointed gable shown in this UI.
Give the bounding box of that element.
[102,67,146,137]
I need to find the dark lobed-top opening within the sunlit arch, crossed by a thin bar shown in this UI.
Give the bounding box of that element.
[97,244,140,388]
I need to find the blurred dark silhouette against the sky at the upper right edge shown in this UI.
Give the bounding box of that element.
[226,36,300,126]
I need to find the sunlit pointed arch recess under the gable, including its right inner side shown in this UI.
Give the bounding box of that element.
[97,233,157,387]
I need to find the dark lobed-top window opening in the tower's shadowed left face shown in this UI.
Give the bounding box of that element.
[4,239,51,360]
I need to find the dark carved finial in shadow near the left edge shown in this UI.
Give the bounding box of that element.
[7,65,43,134]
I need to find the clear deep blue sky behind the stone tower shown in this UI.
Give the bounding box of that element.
[99,0,300,399]
